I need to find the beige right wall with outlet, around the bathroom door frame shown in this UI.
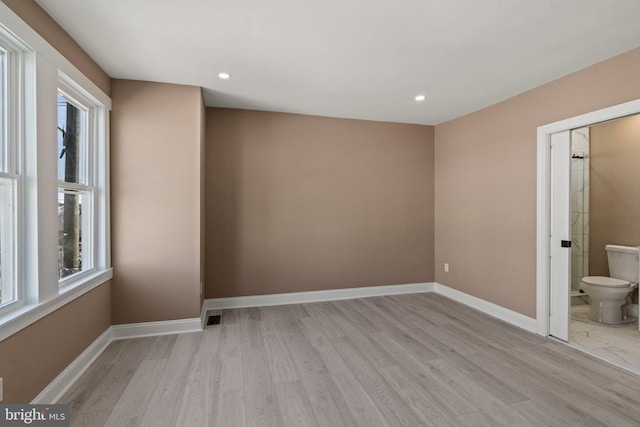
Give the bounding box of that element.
[435,49,640,317]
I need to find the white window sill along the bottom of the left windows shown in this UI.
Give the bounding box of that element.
[0,269,113,341]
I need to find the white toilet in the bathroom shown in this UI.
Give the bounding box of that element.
[580,245,640,325]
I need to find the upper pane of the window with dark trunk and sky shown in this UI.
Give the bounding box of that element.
[58,96,87,184]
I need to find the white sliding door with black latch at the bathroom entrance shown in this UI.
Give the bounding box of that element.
[549,131,571,341]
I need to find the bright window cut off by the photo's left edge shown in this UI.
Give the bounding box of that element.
[0,33,21,309]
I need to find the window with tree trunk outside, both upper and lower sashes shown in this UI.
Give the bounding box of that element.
[57,89,96,286]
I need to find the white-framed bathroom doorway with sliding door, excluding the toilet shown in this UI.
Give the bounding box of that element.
[537,100,640,373]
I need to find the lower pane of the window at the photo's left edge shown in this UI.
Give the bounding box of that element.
[0,178,18,306]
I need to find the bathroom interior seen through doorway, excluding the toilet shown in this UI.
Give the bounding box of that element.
[569,115,640,374]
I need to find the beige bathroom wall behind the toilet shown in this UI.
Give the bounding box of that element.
[589,115,640,276]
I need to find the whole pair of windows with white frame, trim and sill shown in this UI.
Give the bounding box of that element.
[0,0,113,341]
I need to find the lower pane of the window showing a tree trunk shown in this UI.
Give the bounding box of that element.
[58,190,92,279]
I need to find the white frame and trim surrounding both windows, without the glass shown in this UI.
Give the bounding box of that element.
[0,2,113,341]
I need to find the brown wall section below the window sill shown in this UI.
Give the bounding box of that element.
[0,282,111,404]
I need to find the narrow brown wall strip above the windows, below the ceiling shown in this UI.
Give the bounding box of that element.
[1,0,111,95]
